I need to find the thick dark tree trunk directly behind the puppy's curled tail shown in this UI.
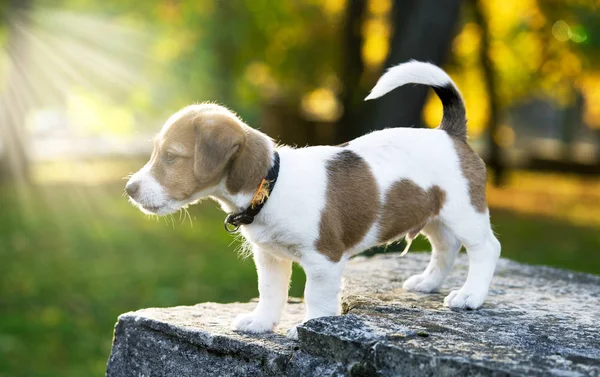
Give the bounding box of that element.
[355,0,461,136]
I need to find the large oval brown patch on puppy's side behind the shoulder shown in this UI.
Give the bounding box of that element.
[316,150,379,262]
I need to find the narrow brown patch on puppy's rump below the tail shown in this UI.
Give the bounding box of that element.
[452,137,487,213]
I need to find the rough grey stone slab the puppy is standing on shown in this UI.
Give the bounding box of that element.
[107,253,600,377]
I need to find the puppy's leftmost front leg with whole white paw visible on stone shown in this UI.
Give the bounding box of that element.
[233,247,292,333]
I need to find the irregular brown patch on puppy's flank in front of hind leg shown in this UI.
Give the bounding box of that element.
[377,179,446,243]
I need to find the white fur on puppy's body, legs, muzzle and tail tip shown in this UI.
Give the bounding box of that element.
[126,62,500,338]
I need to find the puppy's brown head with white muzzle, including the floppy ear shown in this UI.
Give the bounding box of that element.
[126,104,247,215]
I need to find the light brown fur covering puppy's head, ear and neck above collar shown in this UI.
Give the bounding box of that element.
[149,104,271,200]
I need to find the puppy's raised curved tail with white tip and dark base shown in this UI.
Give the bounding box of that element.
[365,60,467,140]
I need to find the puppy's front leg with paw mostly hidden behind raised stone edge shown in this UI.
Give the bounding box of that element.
[287,252,346,339]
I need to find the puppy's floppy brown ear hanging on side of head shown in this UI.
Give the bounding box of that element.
[194,114,246,183]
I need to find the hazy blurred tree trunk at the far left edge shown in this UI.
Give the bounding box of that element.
[0,0,33,184]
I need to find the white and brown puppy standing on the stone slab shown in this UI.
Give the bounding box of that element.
[127,61,500,338]
